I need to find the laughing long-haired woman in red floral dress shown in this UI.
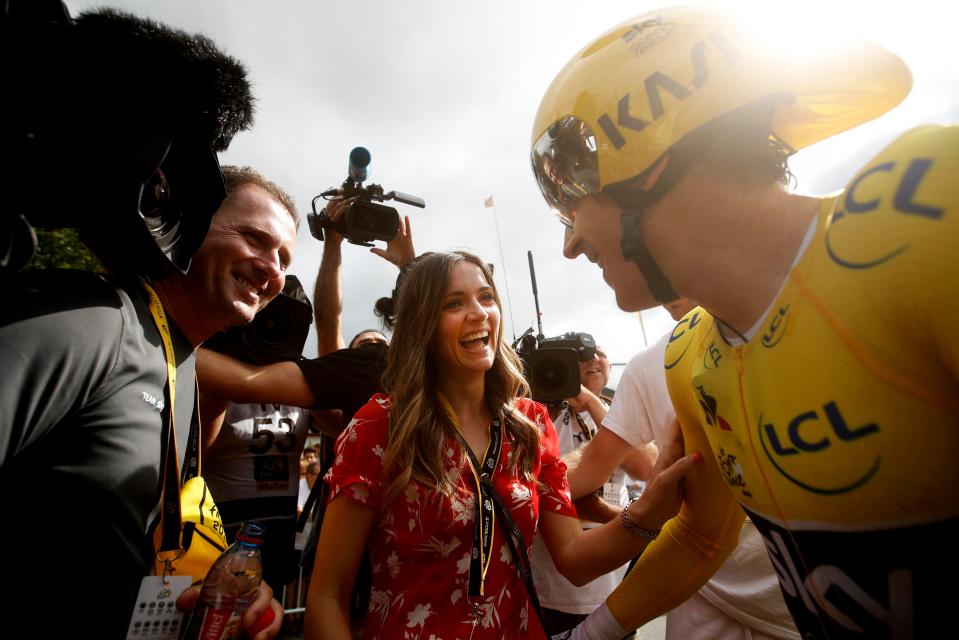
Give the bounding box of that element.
[306,252,699,640]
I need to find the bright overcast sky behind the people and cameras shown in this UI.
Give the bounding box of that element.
[66,0,959,380]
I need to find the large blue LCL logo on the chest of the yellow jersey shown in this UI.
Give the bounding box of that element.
[758,401,881,495]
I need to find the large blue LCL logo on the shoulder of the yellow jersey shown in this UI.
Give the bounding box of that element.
[825,158,945,269]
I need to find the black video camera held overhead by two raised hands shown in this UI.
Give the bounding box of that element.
[306,147,426,247]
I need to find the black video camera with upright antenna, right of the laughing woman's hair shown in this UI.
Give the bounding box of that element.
[513,251,596,406]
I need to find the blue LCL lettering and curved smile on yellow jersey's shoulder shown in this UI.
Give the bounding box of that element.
[826,158,945,269]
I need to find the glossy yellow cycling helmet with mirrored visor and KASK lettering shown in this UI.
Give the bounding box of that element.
[531,7,912,224]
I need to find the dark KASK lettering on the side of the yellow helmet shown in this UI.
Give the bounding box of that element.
[596,32,739,149]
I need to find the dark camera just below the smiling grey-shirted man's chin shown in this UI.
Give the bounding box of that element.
[203,276,313,365]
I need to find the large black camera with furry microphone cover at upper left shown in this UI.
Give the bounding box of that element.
[0,0,253,277]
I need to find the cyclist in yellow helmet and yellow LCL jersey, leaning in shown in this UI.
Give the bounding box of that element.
[531,7,959,638]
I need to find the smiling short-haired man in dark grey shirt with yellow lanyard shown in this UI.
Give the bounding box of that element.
[0,167,297,637]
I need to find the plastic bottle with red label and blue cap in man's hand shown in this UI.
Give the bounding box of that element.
[180,522,265,640]
